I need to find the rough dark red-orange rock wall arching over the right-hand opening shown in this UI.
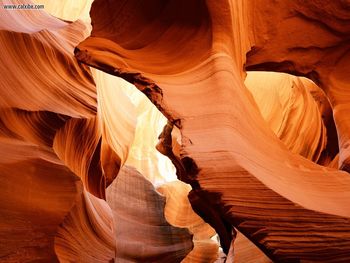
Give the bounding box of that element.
[247,0,350,171]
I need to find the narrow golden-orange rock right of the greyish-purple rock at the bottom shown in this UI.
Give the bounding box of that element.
[157,181,219,263]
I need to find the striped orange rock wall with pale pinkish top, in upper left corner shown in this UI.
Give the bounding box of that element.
[0,1,96,117]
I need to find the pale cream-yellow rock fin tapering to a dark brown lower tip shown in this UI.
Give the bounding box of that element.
[93,70,137,186]
